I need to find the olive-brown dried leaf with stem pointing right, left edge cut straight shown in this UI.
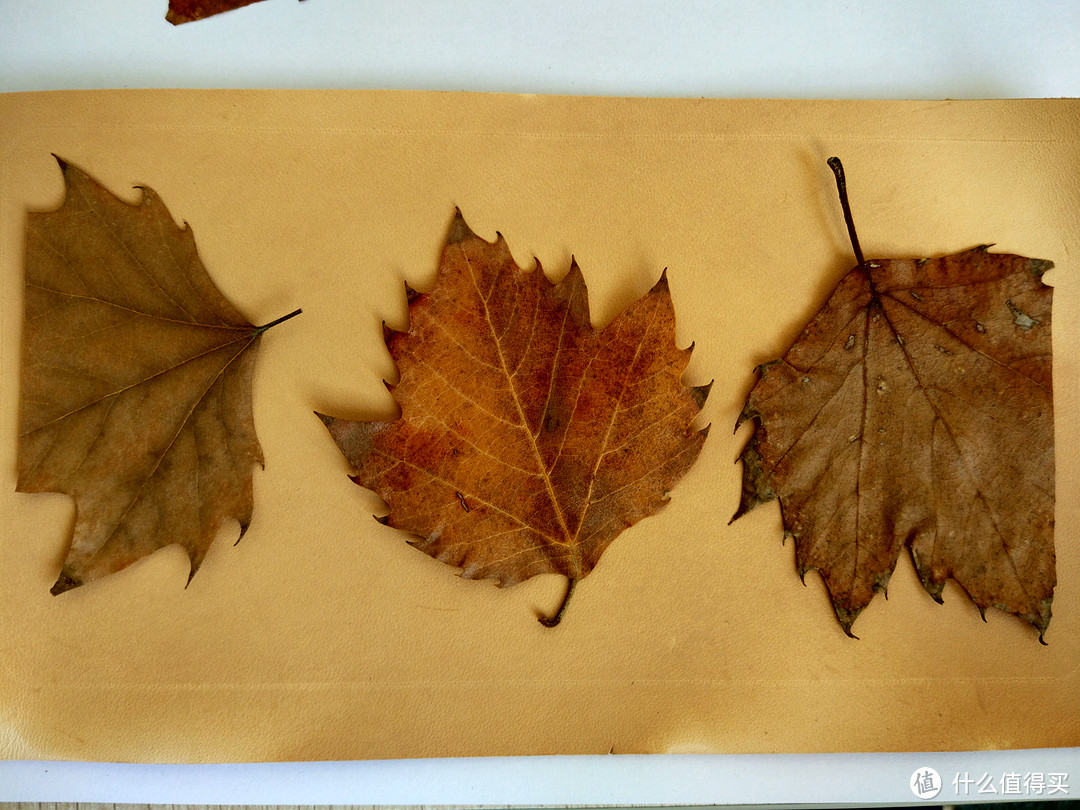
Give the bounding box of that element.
[17,158,299,594]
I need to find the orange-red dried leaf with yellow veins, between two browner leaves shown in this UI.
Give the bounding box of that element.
[320,212,708,626]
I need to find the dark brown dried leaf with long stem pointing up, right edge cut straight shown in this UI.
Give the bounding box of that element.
[731,158,1055,640]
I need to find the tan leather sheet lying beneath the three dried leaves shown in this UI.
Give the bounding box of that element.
[0,91,1080,761]
